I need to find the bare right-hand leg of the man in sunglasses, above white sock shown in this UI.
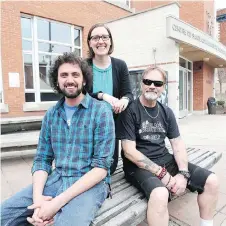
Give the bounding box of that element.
[197,174,219,220]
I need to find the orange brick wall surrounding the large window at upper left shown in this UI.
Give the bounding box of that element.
[1,1,130,117]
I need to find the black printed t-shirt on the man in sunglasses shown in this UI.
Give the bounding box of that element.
[116,98,180,168]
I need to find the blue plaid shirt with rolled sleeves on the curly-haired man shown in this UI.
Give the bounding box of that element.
[32,94,115,192]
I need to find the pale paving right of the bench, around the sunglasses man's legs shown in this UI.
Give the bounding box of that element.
[169,115,226,226]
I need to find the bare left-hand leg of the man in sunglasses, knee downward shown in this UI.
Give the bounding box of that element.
[147,187,169,226]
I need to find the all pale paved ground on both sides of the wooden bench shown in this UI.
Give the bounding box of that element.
[1,115,226,226]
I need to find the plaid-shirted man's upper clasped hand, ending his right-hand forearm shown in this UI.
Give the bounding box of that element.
[28,198,62,221]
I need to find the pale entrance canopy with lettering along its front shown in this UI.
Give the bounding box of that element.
[166,16,226,68]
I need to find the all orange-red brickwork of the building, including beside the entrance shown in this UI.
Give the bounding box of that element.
[1,0,222,117]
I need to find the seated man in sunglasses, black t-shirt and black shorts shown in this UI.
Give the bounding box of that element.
[117,67,218,226]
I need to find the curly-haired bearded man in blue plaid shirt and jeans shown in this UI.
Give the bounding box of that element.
[1,53,115,226]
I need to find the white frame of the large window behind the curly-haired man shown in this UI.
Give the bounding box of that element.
[20,14,82,103]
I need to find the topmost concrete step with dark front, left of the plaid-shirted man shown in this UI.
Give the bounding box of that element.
[1,116,43,134]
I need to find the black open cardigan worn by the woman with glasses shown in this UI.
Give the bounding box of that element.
[87,57,133,103]
